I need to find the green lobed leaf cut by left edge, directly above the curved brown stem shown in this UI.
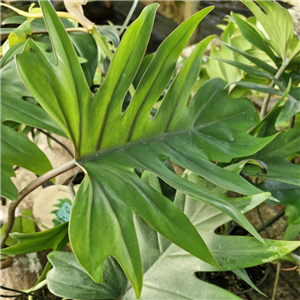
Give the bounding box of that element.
[0,124,52,201]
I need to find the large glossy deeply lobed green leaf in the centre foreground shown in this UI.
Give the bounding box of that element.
[16,1,273,296]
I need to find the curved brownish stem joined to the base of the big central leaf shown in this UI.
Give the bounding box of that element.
[0,160,76,249]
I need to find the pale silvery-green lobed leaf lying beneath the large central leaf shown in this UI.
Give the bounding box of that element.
[47,170,299,300]
